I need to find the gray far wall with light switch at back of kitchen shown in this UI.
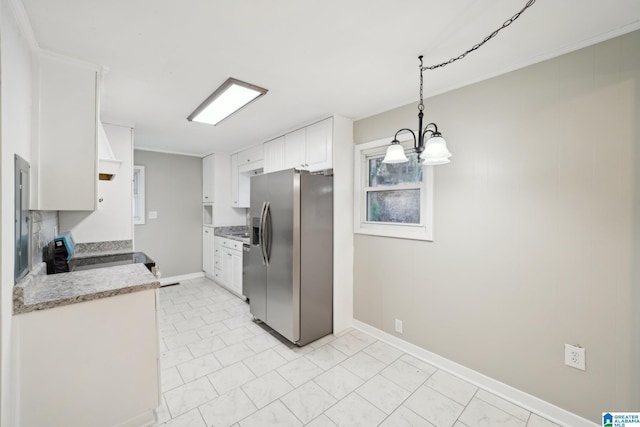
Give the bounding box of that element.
[133,150,202,277]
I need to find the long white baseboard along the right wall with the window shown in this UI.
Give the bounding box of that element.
[353,319,598,427]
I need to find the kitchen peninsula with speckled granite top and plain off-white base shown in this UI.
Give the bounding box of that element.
[14,263,160,427]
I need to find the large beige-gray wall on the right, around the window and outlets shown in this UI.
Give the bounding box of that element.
[354,32,640,424]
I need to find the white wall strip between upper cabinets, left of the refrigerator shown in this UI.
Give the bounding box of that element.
[213,154,247,227]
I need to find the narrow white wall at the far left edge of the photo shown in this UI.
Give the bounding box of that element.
[0,0,32,426]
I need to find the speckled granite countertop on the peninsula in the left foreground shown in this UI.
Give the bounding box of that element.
[13,263,160,315]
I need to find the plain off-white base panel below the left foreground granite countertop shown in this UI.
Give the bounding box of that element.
[13,289,161,427]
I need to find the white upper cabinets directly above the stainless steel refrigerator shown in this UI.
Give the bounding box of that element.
[264,117,333,173]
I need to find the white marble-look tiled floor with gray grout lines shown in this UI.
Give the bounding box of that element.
[152,279,557,427]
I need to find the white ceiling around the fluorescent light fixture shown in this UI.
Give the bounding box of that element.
[16,0,640,155]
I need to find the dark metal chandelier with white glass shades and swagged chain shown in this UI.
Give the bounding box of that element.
[382,0,536,166]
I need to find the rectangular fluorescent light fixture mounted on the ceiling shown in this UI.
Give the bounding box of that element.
[187,77,267,125]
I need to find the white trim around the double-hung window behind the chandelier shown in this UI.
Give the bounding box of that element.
[353,135,434,241]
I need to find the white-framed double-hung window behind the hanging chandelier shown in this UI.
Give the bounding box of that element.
[354,138,433,240]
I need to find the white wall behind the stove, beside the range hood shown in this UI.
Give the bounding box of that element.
[59,123,133,243]
